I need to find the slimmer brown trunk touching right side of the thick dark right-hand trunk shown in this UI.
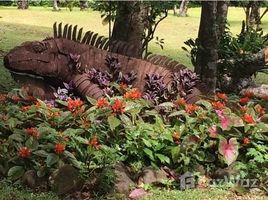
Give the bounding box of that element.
[216,0,229,41]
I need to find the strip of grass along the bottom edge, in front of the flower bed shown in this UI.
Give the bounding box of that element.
[0,181,268,200]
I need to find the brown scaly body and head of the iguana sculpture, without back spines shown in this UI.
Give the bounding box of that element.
[4,23,200,102]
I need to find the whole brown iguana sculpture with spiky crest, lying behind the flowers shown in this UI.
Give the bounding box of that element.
[4,23,200,102]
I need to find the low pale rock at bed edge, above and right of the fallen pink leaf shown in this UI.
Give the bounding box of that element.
[142,168,168,184]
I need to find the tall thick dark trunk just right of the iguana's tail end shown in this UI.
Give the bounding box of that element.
[195,1,218,94]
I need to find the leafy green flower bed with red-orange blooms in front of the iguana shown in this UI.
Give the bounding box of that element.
[0,88,268,188]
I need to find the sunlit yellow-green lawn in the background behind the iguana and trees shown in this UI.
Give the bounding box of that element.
[0,7,268,92]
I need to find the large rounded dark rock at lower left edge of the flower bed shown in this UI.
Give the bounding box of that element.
[49,165,83,195]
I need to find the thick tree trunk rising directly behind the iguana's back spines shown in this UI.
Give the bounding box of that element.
[112,1,147,58]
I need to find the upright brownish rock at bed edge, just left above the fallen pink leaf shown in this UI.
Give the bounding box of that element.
[114,163,135,195]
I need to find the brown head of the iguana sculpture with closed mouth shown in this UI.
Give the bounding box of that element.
[4,39,67,76]
